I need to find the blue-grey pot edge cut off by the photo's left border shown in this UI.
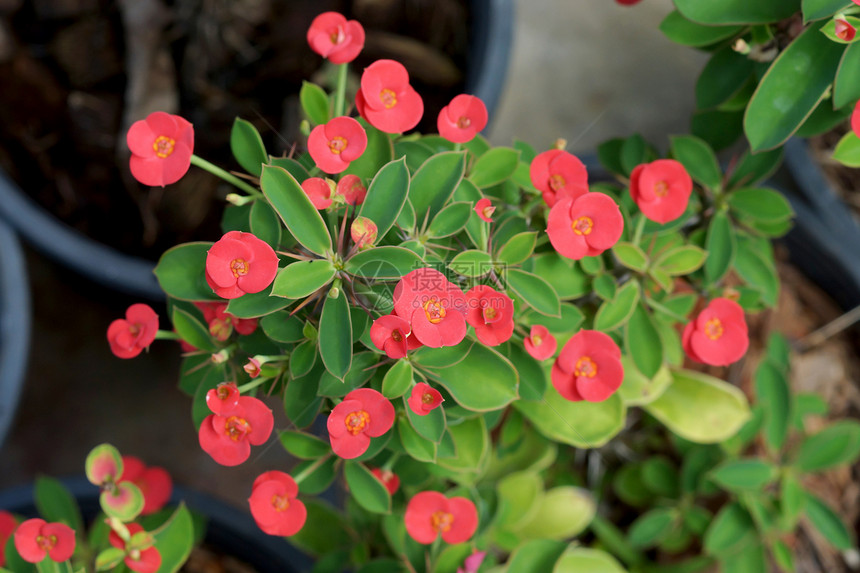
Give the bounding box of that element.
[0,221,31,450]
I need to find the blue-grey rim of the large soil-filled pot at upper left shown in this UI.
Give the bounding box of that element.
[0,0,514,301]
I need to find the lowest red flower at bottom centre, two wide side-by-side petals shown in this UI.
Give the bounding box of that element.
[404,491,478,545]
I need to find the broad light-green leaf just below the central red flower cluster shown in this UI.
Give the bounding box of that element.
[414,344,519,412]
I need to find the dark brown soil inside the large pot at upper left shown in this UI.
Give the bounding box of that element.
[0,0,469,259]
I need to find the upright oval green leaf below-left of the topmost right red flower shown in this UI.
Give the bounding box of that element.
[408,151,466,225]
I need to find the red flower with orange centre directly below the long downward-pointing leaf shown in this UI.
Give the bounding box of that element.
[328,388,394,460]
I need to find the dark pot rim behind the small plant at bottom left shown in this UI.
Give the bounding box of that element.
[0,478,313,573]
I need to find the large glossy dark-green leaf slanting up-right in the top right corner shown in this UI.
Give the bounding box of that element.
[744,23,844,152]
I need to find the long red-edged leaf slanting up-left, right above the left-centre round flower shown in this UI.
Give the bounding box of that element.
[260,165,331,257]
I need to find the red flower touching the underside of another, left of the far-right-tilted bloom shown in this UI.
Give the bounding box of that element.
[546,193,624,260]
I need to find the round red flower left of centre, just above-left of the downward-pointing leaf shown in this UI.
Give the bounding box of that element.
[206,231,278,299]
